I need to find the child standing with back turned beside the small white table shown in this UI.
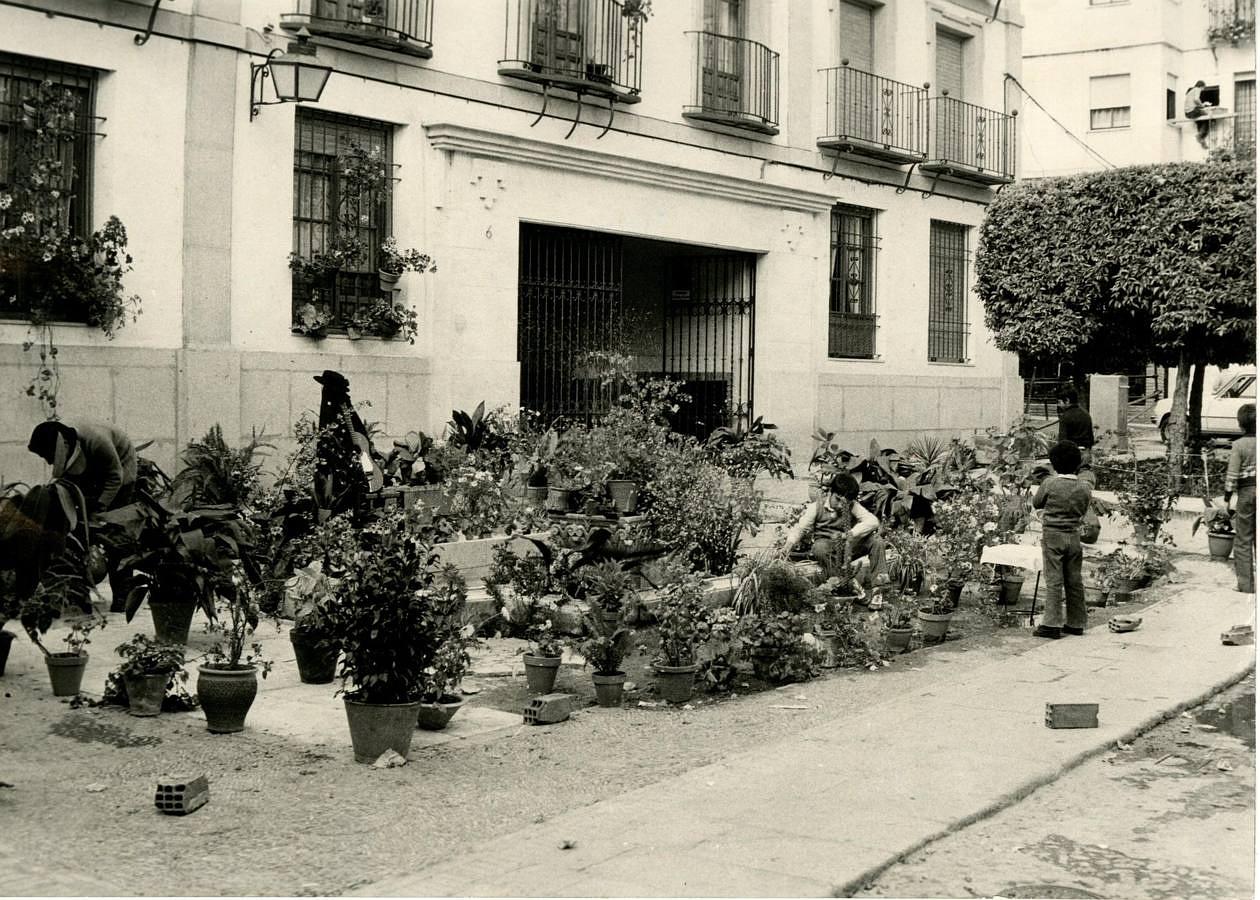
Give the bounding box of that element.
[1032,441,1090,638]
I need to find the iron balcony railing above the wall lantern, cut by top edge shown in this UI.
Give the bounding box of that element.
[280,0,433,59]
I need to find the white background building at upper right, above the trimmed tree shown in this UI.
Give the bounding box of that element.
[1021,0,1256,178]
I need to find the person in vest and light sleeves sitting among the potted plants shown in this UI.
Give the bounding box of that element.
[782,473,885,594]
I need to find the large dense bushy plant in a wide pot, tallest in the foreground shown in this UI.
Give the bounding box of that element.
[331,508,449,763]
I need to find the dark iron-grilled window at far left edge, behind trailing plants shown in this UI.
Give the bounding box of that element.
[0,53,96,320]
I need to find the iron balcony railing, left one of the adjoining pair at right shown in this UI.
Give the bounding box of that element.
[818,61,927,163]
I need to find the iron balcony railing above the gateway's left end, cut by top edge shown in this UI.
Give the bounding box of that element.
[499,0,644,103]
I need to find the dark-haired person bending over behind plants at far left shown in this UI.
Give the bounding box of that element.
[26,420,137,611]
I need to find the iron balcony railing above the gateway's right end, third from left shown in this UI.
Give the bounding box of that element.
[683,32,779,135]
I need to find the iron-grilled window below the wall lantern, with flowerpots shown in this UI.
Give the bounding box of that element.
[292,108,393,326]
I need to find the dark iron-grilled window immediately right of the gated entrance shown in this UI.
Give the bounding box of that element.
[827,205,879,359]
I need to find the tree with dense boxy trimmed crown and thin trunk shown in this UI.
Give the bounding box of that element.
[975,163,1256,478]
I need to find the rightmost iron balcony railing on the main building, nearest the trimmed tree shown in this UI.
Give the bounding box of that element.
[919,96,1016,184]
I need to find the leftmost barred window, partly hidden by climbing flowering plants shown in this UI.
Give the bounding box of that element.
[0,53,97,321]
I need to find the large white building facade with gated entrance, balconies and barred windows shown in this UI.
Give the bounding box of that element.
[0,0,1022,480]
